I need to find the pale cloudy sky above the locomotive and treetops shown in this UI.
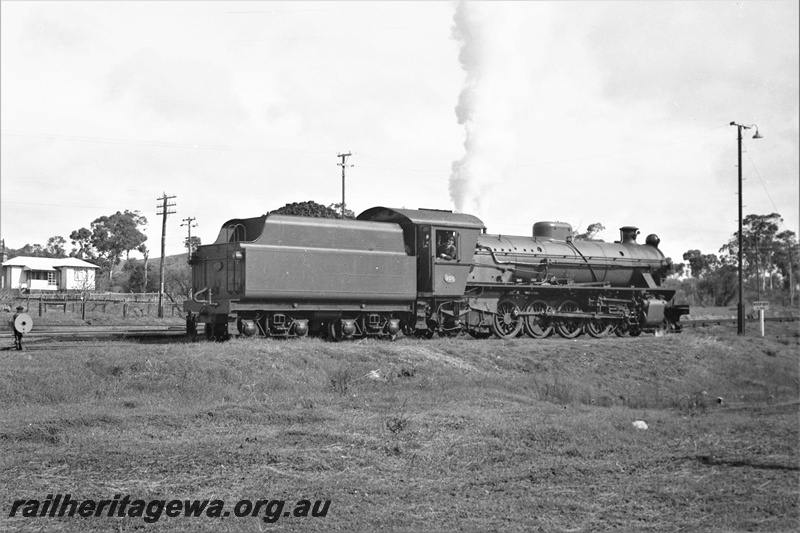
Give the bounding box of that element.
[0,0,800,261]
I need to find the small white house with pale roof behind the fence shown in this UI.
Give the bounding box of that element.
[0,256,100,292]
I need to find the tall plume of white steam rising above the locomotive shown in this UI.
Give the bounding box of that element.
[450,0,530,216]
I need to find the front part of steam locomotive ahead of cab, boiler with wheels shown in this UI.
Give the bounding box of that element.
[467,222,688,338]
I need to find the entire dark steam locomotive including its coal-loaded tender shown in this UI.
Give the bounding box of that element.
[184,207,688,340]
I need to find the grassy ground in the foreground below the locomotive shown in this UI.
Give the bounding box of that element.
[0,310,800,532]
